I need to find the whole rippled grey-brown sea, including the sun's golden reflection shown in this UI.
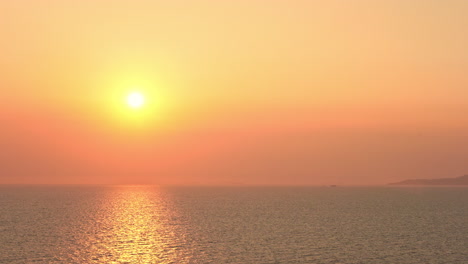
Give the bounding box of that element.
[0,186,468,264]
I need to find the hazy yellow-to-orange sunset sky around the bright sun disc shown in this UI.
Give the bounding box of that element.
[0,0,468,185]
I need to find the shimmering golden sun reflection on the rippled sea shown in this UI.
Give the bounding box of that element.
[72,186,190,263]
